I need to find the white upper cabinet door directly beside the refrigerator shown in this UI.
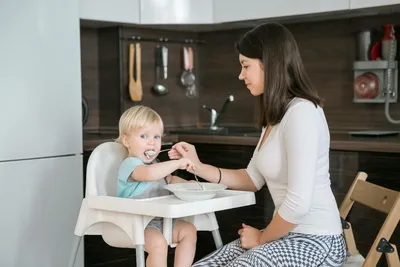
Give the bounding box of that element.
[79,0,140,24]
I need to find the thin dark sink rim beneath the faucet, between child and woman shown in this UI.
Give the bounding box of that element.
[169,127,261,137]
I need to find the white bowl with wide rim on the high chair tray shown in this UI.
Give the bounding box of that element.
[164,182,227,201]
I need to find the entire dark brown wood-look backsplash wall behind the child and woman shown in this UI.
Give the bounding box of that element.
[81,14,400,134]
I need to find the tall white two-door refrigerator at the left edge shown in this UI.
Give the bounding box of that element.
[0,0,83,267]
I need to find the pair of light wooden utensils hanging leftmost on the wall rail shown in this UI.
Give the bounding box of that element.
[129,43,143,101]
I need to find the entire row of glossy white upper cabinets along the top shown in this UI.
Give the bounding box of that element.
[79,0,400,25]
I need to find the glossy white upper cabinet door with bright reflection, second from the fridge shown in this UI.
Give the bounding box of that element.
[140,0,213,24]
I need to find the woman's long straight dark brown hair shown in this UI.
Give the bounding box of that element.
[236,23,322,127]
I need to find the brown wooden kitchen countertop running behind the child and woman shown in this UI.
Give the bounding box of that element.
[83,132,400,153]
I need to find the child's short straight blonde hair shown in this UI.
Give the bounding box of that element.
[115,105,164,144]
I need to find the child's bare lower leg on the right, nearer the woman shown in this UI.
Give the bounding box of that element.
[172,221,197,267]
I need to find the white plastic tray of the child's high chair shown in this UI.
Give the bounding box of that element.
[87,190,256,218]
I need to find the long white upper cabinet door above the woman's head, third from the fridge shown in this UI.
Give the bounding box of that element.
[214,0,350,23]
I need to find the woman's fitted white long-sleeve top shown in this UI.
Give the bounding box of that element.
[246,98,342,235]
